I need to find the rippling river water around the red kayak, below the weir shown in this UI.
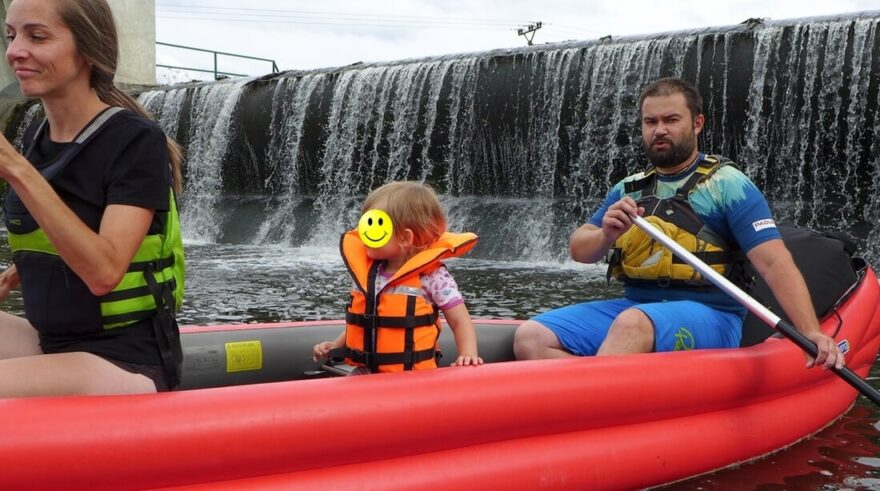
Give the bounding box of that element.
[0,233,880,490]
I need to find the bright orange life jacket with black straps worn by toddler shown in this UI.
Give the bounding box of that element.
[340,230,477,372]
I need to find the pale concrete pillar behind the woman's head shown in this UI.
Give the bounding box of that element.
[0,0,156,94]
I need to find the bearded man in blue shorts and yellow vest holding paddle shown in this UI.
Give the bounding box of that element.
[514,78,844,368]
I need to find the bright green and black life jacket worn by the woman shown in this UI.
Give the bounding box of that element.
[6,108,185,332]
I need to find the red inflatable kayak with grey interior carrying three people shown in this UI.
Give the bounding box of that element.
[0,270,880,490]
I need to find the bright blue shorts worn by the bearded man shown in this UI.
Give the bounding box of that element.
[532,298,743,356]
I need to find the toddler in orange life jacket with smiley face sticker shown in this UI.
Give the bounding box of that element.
[313,181,483,373]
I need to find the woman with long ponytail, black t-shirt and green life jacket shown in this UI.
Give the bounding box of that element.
[0,0,183,397]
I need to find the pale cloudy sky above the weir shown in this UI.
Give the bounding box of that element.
[155,0,880,80]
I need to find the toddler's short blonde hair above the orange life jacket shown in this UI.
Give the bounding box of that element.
[361,181,446,251]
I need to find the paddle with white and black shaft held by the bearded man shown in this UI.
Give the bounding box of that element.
[631,216,880,406]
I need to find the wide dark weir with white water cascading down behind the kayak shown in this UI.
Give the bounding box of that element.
[6,11,880,264]
